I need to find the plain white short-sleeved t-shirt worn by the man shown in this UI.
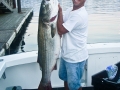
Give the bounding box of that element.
[61,6,88,63]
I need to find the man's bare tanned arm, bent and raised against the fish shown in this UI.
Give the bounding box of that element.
[57,5,68,36]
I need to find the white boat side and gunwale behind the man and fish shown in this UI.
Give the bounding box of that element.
[0,43,120,90]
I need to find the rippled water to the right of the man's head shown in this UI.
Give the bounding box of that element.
[86,0,120,14]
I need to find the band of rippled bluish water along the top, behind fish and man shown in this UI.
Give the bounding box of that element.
[21,0,120,16]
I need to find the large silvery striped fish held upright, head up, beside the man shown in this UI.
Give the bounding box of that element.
[38,0,60,90]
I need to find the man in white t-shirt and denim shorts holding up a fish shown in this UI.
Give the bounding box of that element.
[57,0,88,90]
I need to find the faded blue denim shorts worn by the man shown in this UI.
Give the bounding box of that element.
[59,58,86,90]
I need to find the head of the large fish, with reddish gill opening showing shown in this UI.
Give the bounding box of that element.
[40,0,58,23]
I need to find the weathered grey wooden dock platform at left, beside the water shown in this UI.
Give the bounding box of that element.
[0,8,33,56]
